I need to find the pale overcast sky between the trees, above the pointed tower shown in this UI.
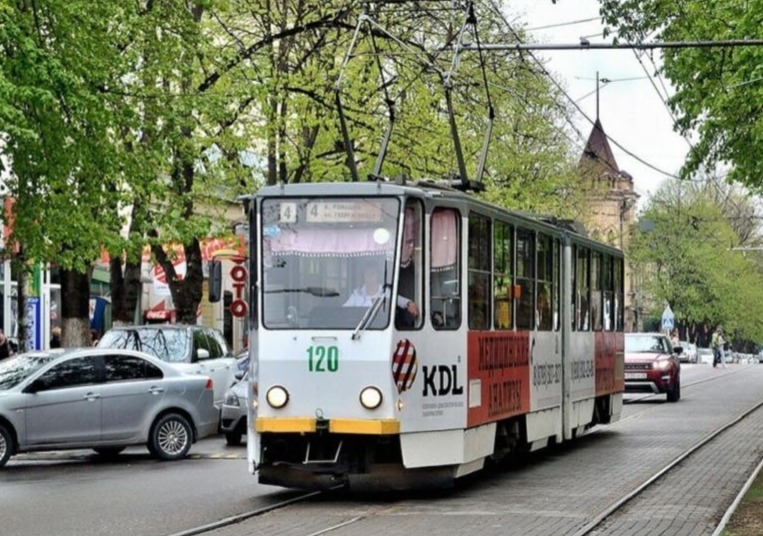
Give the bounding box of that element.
[506,0,689,204]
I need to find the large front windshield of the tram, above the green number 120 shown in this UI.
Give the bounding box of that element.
[261,197,400,330]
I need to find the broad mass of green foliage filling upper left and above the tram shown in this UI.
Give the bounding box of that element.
[0,0,592,326]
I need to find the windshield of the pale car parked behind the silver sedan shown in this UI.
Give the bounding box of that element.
[98,328,190,363]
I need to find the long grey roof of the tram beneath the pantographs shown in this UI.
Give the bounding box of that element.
[248,180,622,254]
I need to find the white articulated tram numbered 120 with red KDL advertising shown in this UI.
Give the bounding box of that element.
[247,182,624,489]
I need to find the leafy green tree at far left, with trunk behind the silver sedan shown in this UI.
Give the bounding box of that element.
[0,0,134,344]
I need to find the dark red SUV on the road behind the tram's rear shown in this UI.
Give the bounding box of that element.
[625,333,683,402]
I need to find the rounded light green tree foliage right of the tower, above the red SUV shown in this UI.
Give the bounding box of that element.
[628,179,763,340]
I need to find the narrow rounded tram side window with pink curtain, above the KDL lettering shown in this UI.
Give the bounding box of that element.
[429,208,461,329]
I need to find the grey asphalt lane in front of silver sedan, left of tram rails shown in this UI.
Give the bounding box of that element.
[0,437,298,536]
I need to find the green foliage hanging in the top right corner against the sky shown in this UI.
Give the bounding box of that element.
[601,0,763,189]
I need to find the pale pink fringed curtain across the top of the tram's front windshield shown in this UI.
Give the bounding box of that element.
[264,228,394,257]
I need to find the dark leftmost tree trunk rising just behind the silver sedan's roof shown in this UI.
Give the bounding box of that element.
[61,268,93,347]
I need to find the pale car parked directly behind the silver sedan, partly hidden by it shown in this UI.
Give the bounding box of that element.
[98,324,237,409]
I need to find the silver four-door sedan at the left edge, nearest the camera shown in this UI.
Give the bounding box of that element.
[0,348,218,467]
